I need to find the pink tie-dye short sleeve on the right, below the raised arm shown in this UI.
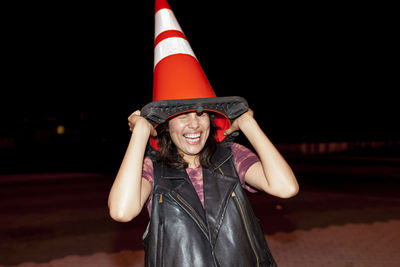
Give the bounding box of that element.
[231,142,260,193]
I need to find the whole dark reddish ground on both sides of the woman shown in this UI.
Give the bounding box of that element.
[0,155,400,267]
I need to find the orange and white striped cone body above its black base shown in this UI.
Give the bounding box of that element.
[153,0,216,101]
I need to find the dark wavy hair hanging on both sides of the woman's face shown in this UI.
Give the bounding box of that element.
[155,114,217,169]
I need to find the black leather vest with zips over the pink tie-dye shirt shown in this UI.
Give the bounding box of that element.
[143,144,276,267]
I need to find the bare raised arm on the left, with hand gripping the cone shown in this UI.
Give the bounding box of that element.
[108,111,157,222]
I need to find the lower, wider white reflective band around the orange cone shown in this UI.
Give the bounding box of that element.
[154,37,197,68]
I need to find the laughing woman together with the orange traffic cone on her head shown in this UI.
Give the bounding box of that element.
[108,0,298,267]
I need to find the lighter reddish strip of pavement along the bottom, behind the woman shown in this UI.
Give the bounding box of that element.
[3,220,400,267]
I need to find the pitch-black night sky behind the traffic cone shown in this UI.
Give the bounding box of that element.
[1,0,399,141]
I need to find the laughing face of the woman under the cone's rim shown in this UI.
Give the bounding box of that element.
[169,112,210,156]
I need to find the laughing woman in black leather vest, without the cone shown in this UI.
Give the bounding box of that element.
[109,109,299,266]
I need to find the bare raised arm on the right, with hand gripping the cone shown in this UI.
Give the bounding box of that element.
[225,110,299,198]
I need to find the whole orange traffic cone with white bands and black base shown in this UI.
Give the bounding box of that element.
[141,0,248,150]
